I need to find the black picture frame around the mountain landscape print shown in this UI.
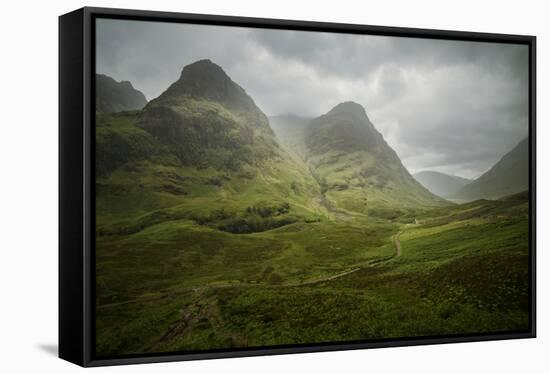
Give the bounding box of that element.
[59,7,536,366]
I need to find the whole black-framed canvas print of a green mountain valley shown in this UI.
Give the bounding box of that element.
[59,8,535,366]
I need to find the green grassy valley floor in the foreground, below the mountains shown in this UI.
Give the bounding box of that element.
[97,151,528,354]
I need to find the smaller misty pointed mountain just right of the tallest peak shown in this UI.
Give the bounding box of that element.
[305,102,445,218]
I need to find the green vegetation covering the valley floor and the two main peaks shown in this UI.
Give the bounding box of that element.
[96,61,529,356]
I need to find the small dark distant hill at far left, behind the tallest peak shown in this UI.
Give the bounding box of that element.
[95,74,147,113]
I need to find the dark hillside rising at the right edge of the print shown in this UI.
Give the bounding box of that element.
[454,138,529,201]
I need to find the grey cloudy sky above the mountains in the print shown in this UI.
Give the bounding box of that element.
[96,19,528,178]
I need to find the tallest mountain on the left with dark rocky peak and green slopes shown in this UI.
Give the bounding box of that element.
[96,60,324,235]
